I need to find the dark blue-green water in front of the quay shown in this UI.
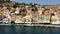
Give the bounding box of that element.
[0,26,60,34]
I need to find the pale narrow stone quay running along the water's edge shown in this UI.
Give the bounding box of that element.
[0,24,60,28]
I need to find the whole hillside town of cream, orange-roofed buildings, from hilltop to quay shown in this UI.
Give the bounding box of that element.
[0,1,60,27]
